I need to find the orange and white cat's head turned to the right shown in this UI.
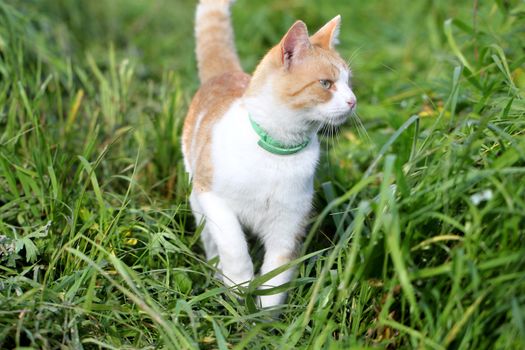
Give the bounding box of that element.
[250,16,356,131]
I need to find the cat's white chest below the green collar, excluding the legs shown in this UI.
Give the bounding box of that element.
[212,101,319,210]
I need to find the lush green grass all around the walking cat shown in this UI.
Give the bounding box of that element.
[0,0,525,350]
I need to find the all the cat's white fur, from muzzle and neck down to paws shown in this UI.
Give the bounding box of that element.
[187,69,355,307]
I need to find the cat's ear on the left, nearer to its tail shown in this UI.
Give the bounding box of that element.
[281,21,312,68]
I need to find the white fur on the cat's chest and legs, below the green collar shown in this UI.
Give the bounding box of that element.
[190,101,319,307]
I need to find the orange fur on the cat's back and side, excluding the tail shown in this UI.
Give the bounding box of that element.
[182,72,250,190]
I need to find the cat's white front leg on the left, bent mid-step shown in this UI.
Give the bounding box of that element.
[195,192,253,286]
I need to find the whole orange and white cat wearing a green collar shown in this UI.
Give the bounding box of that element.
[182,0,356,307]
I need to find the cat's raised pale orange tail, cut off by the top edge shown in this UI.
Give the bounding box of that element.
[195,0,242,83]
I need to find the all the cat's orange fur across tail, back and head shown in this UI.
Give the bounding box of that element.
[186,6,347,192]
